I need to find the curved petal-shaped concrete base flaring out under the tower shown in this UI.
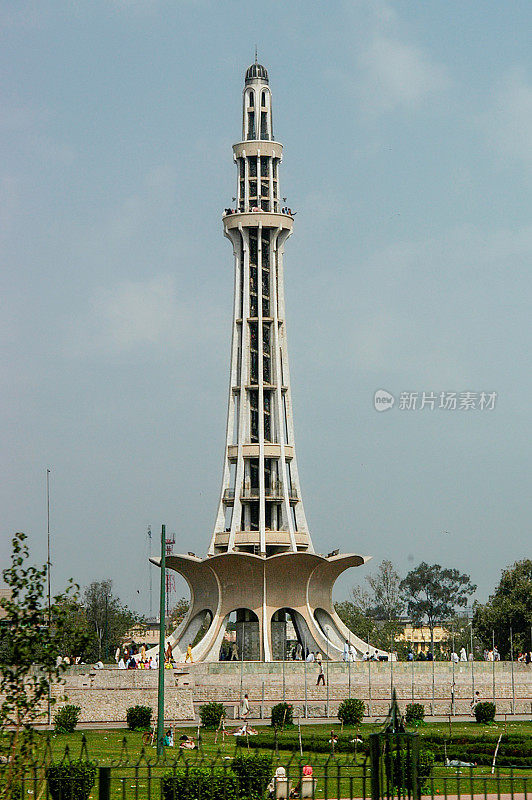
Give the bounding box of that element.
[147,552,385,661]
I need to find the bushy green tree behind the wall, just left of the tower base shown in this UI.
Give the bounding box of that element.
[82,579,144,661]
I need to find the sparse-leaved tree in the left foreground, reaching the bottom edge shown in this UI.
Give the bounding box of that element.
[0,533,88,798]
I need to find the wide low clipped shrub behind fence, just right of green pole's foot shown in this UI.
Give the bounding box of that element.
[162,767,239,800]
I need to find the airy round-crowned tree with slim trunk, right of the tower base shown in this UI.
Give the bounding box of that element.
[400,561,477,653]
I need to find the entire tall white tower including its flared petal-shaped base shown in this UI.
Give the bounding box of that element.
[154,62,374,661]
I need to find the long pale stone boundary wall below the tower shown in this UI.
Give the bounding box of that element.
[35,661,532,723]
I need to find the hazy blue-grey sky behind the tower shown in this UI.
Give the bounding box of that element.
[0,0,532,611]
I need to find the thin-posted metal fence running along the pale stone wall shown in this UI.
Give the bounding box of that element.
[202,659,532,718]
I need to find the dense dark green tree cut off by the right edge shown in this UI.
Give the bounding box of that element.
[473,558,532,657]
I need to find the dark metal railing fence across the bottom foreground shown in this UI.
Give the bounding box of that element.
[2,737,532,800]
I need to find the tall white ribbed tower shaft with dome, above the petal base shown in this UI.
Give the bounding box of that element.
[209,60,314,557]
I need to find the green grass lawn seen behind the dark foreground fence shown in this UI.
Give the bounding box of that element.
[16,722,532,800]
